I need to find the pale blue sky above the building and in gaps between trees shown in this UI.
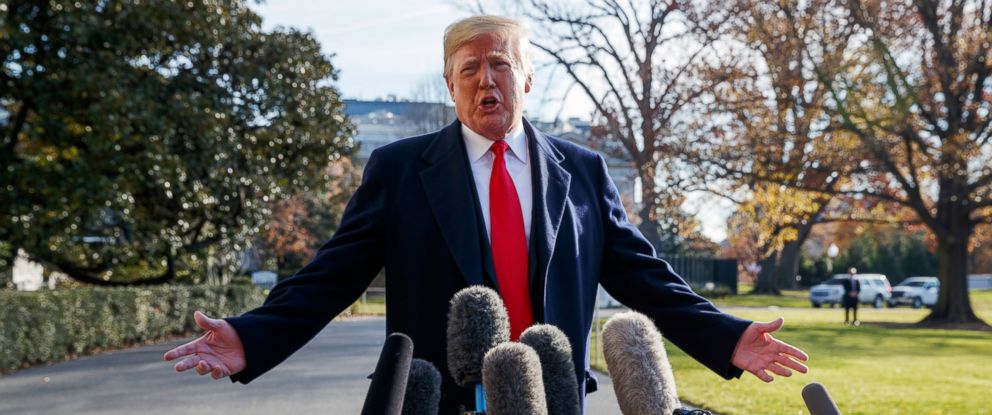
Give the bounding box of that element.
[252,0,730,241]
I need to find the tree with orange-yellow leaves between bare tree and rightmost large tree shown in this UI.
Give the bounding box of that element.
[692,0,850,294]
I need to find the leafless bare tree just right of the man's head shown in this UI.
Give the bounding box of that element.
[520,0,724,250]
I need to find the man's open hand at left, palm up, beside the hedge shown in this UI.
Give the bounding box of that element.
[165,311,248,379]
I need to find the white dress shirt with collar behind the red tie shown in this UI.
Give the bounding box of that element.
[462,124,533,246]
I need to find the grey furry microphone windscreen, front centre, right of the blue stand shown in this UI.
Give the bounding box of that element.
[482,342,548,415]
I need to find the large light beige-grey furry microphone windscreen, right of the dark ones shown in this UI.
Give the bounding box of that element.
[603,311,682,415]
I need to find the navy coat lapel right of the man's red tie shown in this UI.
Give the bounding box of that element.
[524,120,572,306]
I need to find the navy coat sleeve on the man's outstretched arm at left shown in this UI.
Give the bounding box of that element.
[226,152,387,383]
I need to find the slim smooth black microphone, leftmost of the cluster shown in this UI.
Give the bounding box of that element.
[362,333,413,415]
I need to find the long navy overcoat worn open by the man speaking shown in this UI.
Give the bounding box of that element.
[228,120,750,413]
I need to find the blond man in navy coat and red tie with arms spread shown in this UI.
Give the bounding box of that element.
[165,16,807,414]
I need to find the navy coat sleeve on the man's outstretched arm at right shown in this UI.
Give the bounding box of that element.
[598,157,751,379]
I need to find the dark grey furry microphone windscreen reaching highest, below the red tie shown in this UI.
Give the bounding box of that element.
[447,285,510,387]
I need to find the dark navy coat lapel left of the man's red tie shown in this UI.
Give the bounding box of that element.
[420,121,483,285]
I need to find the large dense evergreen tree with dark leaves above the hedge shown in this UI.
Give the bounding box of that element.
[0,0,353,284]
